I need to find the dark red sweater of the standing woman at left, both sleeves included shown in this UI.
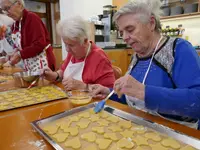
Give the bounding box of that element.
[12,9,56,70]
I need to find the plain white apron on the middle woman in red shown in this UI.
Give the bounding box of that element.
[63,43,91,81]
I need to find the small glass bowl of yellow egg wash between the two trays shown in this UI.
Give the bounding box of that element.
[67,90,92,106]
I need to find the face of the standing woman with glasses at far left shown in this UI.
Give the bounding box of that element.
[1,0,23,21]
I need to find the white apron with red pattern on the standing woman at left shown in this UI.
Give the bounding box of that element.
[11,19,50,72]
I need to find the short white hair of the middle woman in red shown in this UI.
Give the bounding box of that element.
[57,16,89,44]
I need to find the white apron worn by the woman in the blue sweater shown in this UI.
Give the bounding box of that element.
[125,36,198,129]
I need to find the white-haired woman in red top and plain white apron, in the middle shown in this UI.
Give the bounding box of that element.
[44,16,115,90]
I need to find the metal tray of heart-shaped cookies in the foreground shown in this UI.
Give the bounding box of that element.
[31,103,200,150]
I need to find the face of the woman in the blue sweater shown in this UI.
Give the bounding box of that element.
[117,13,154,54]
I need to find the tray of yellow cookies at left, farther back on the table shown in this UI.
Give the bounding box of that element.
[0,85,67,111]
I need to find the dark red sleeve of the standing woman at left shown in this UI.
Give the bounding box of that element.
[20,14,49,59]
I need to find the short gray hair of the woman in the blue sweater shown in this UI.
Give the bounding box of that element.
[113,0,162,31]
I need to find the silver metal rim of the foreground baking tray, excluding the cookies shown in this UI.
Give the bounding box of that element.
[31,102,200,150]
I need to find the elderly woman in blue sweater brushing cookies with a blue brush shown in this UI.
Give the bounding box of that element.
[90,0,200,127]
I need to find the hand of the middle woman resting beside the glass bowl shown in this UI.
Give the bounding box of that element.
[62,77,87,91]
